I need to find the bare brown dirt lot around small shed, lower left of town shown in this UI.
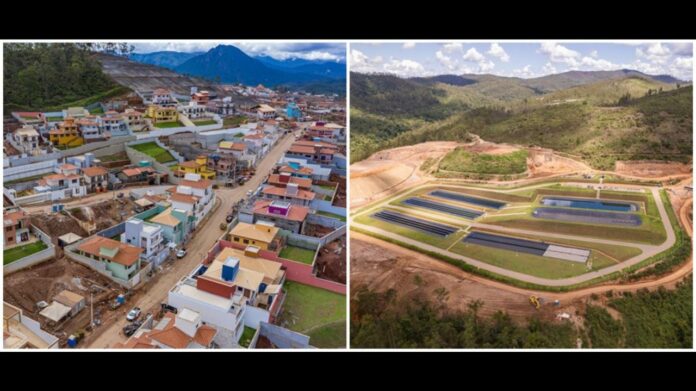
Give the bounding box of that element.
[3,257,125,347]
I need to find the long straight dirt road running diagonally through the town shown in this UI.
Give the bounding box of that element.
[82,135,295,349]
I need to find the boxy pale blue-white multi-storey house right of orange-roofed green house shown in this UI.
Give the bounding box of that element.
[121,218,169,266]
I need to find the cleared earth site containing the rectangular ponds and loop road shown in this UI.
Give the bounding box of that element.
[351,139,693,330]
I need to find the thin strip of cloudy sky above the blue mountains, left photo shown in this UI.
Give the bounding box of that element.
[130,41,346,61]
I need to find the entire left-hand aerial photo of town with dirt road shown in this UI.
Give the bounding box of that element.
[2,41,346,350]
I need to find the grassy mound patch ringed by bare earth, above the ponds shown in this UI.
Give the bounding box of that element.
[439,148,527,175]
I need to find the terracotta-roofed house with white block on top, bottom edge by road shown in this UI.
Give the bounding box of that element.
[114,308,217,349]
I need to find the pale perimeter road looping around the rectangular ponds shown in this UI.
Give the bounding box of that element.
[350,183,676,287]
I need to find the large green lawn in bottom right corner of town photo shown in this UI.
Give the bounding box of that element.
[281,281,346,348]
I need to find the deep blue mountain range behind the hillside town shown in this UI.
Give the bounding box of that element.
[130,45,346,95]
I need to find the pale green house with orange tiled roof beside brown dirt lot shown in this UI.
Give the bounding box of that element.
[76,236,143,281]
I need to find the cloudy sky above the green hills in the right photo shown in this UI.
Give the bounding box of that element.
[350,41,693,80]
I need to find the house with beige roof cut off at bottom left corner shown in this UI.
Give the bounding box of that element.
[2,302,60,349]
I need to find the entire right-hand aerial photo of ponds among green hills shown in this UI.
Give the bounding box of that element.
[349,42,693,349]
